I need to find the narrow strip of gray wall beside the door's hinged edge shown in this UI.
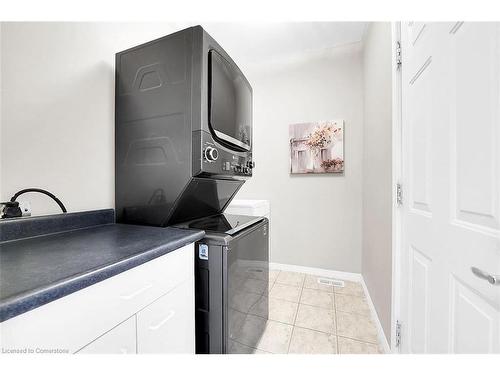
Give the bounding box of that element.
[362,22,392,339]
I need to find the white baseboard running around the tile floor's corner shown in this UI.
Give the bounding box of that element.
[269,263,391,353]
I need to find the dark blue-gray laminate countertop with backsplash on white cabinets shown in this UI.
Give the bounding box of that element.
[0,210,205,322]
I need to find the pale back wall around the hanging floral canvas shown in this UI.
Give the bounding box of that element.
[237,44,363,272]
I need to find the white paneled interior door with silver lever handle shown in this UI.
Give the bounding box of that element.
[399,22,500,353]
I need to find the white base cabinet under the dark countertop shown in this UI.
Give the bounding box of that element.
[0,244,194,353]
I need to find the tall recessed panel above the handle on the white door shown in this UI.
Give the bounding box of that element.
[450,23,500,230]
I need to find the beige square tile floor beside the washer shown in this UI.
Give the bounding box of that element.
[230,270,383,354]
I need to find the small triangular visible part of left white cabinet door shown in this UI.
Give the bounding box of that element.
[78,315,136,354]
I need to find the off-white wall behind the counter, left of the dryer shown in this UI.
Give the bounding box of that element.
[0,23,188,214]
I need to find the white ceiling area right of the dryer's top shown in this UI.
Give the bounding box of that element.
[202,22,366,65]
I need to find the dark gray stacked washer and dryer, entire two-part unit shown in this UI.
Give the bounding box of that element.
[115,26,269,353]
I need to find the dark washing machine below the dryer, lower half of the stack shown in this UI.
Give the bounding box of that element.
[177,214,269,354]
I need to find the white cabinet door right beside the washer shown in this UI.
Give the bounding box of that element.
[137,278,195,354]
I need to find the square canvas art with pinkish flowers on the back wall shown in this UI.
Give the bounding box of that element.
[289,120,344,174]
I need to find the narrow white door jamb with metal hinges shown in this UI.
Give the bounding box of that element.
[391,22,404,353]
